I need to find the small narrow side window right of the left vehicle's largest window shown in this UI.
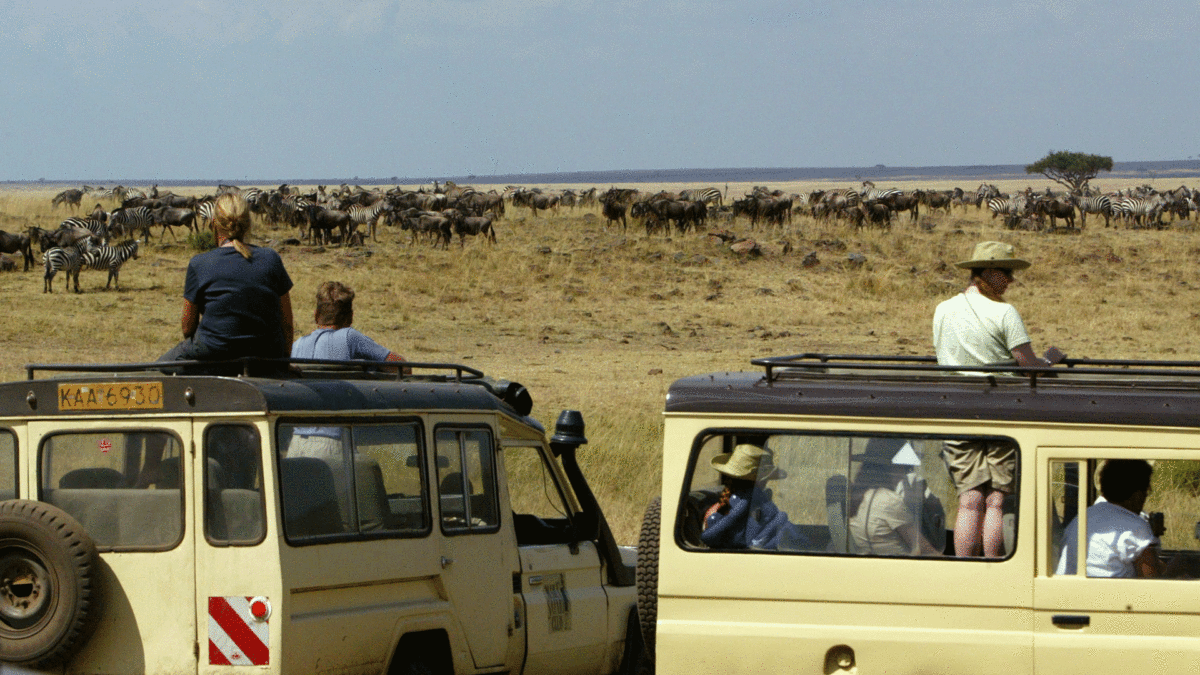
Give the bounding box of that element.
[434,426,499,532]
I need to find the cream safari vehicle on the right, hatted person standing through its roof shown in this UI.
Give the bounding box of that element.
[637,354,1200,675]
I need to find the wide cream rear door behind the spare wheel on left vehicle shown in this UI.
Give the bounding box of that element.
[28,415,197,674]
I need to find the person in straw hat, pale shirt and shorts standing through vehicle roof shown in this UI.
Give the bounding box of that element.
[934,241,1066,557]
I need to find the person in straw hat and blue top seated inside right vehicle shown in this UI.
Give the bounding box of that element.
[700,443,797,549]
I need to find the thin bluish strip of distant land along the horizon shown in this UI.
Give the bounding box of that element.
[7,159,1200,186]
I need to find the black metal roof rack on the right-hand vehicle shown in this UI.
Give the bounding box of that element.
[750,352,1200,387]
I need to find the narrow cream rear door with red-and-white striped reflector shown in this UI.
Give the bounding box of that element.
[188,419,276,673]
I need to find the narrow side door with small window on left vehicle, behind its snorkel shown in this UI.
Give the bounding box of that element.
[433,422,520,668]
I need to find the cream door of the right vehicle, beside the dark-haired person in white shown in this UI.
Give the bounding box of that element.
[1033,443,1200,674]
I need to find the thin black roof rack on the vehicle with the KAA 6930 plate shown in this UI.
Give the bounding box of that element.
[25,357,485,382]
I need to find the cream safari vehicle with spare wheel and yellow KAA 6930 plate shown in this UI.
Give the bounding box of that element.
[0,360,640,675]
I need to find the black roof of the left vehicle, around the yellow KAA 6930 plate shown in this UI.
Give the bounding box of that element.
[0,359,540,420]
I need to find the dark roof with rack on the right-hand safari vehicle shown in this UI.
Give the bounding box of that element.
[666,354,1200,426]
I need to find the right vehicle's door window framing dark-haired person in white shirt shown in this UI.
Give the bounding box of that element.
[1049,458,1200,579]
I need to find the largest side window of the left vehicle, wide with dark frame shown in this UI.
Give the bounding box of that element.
[278,423,430,540]
